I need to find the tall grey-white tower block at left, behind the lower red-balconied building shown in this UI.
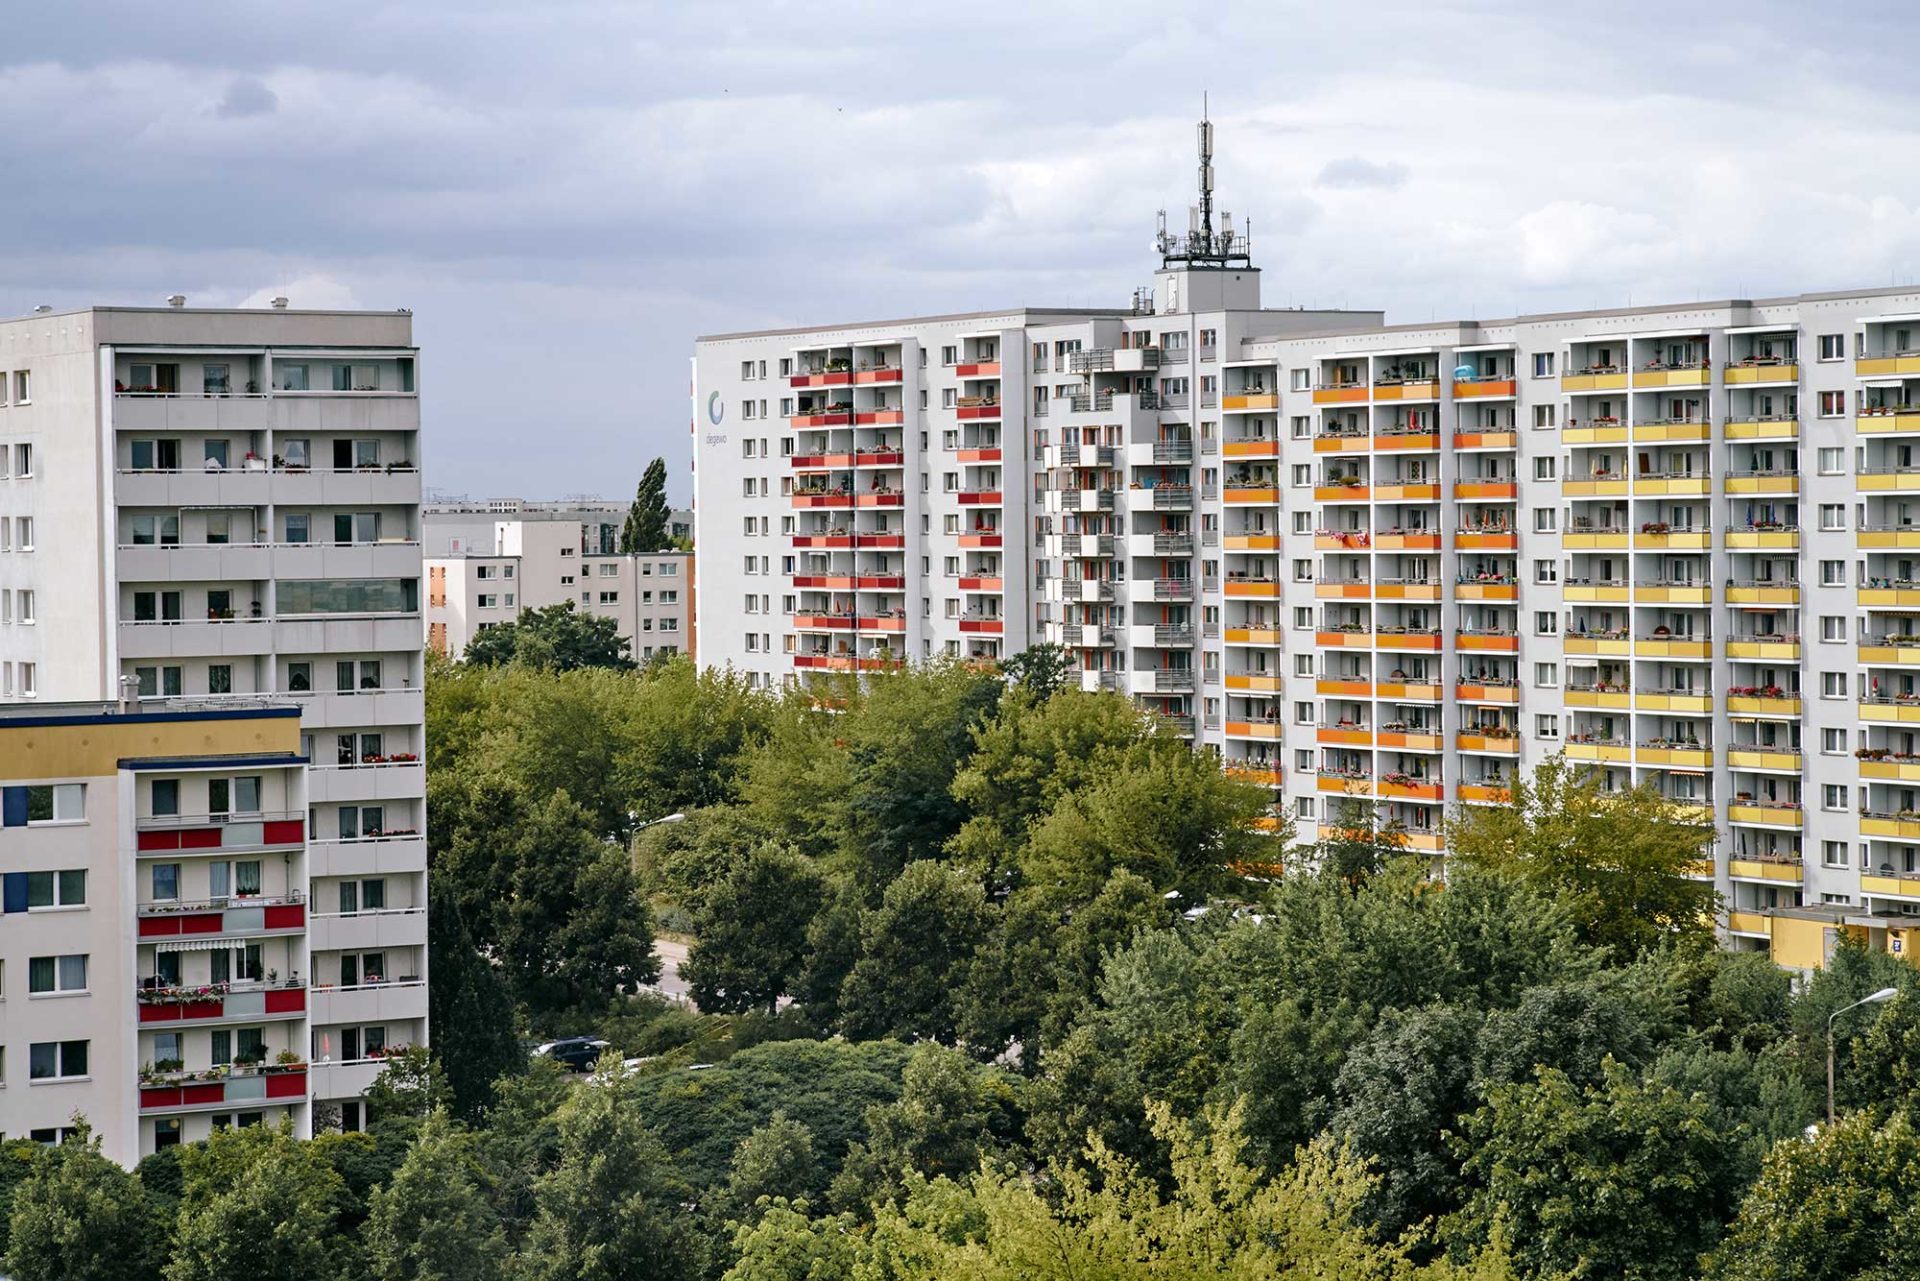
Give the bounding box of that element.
[0,303,426,1150]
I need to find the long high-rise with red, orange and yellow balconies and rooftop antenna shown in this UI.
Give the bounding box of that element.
[693,117,1920,966]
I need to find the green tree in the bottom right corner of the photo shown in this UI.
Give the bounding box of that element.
[1707,1112,1920,1281]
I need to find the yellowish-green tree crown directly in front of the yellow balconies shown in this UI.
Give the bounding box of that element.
[1446,757,1718,956]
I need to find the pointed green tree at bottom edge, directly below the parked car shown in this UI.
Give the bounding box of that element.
[520,1066,703,1281]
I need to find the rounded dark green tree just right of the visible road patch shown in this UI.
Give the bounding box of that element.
[682,845,826,1014]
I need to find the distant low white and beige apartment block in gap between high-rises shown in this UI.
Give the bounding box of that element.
[424,499,695,663]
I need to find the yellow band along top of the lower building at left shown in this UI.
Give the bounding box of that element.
[0,714,300,784]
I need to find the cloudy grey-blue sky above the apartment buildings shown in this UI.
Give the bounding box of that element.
[0,0,1920,497]
